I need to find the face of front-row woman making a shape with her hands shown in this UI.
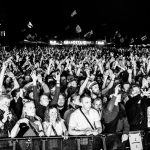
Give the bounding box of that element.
[25,102,36,116]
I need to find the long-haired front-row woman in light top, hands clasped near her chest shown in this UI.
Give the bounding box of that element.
[43,106,68,150]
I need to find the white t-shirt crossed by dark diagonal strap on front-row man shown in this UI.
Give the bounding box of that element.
[69,108,100,130]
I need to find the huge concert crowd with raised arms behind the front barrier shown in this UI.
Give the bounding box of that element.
[0,45,150,149]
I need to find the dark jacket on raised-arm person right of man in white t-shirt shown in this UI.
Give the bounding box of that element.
[102,96,130,134]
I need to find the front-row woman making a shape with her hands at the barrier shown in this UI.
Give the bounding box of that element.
[10,101,44,150]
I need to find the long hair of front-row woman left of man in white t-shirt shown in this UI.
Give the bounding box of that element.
[44,105,61,122]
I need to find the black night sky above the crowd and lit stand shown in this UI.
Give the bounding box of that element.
[0,0,150,44]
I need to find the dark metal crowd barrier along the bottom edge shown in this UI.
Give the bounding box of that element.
[0,131,150,150]
